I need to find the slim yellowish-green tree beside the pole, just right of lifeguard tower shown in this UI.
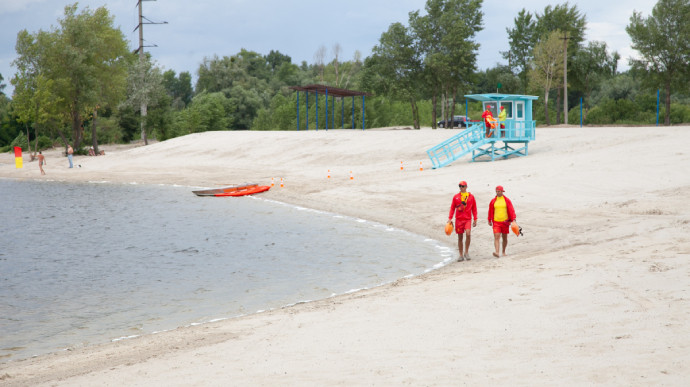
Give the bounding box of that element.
[530,30,563,125]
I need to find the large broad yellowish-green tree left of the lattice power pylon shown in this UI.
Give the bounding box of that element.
[13,4,129,148]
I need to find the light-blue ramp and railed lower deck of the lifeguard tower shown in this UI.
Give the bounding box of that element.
[426,121,536,169]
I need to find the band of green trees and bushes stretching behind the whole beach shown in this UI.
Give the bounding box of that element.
[0,0,690,152]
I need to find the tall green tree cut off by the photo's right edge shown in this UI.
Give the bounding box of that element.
[625,0,690,125]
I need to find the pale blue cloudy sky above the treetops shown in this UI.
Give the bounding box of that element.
[0,0,656,95]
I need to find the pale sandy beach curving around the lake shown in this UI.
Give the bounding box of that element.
[0,126,690,386]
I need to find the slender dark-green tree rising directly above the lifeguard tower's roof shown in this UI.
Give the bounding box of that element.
[501,8,538,94]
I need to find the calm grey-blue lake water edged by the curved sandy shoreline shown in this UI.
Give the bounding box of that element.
[0,179,452,362]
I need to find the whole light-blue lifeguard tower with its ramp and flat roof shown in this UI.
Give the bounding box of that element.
[426,93,539,169]
